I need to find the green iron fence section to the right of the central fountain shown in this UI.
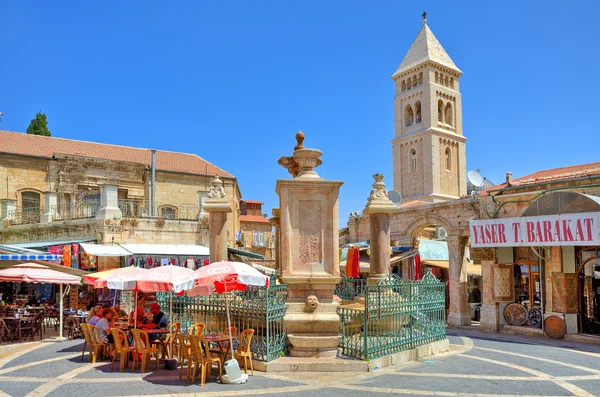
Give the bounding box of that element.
[338,272,446,360]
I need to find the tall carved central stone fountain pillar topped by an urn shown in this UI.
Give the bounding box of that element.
[276,132,343,357]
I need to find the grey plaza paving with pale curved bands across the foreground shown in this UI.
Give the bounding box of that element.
[0,330,600,397]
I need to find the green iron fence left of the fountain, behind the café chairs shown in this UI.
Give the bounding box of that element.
[157,283,287,361]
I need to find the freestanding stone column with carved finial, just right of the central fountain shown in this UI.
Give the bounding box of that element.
[363,174,398,285]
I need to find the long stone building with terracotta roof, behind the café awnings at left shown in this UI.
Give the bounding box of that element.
[0,131,241,270]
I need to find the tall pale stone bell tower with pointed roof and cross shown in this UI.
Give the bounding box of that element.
[392,13,467,202]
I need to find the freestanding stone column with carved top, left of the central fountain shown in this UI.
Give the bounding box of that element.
[203,176,233,263]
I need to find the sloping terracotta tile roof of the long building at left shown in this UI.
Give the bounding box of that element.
[0,131,234,178]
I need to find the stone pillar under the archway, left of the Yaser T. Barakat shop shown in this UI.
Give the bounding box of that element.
[446,236,471,327]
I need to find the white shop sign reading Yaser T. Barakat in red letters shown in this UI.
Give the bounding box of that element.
[469,212,600,247]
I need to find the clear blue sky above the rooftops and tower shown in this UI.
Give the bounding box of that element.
[0,0,600,220]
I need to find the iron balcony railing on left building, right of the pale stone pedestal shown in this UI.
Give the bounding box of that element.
[118,200,200,221]
